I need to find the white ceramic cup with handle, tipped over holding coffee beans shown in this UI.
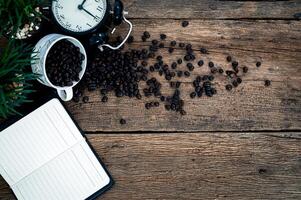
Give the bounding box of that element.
[31,34,87,101]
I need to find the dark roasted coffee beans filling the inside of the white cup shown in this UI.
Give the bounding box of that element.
[46,40,85,87]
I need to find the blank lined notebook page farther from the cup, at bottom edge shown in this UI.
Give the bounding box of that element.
[12,141,110,200]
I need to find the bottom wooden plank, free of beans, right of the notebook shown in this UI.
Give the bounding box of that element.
[0,132,301,200]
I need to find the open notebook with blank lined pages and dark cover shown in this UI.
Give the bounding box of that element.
[0,98,113,200]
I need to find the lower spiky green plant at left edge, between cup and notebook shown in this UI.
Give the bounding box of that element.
[0,40,36,118]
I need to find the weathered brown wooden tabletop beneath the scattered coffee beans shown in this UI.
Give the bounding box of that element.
[0,0,301,200]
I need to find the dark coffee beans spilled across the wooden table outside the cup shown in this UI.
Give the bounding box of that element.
[74,21,270,120]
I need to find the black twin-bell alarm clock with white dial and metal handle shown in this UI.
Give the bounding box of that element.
[51,0,132,49]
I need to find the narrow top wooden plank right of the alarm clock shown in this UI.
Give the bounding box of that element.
[124,0,301,19]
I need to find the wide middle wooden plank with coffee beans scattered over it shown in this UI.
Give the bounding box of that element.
[67,20,301,131]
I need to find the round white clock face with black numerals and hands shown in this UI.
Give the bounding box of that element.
[52,0,107,34]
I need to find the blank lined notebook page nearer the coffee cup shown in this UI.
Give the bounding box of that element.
[0,99,82,185]
